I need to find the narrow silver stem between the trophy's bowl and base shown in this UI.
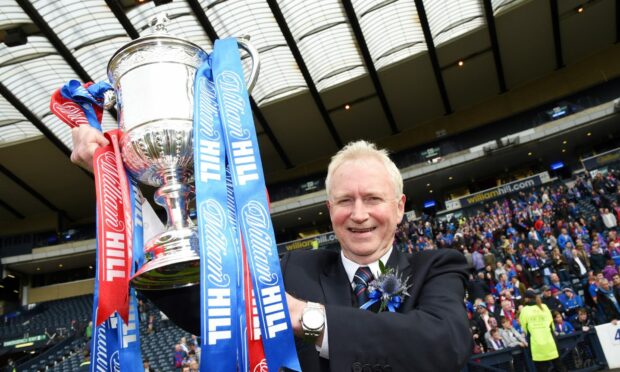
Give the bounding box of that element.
[155,180,194,230]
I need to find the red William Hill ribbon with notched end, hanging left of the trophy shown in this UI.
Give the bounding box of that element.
[93,130,133,326]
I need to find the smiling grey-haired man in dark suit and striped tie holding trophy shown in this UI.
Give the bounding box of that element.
[282,141,472,371]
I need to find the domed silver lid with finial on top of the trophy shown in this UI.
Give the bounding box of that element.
[107,13,207,87]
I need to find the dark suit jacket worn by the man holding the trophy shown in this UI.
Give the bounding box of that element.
[282,249,472,372]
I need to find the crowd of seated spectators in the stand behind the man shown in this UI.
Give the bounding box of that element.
[394,170,620,360]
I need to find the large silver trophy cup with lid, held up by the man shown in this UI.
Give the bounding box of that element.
[108,16,259,290]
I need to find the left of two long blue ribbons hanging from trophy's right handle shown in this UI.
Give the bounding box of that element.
[194,58,245,372]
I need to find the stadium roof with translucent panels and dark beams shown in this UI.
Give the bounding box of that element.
[0,0,620,235]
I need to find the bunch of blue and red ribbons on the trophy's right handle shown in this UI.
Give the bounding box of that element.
[194,39,300,372]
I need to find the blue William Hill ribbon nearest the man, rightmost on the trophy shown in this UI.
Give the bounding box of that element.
[211,38,301,371]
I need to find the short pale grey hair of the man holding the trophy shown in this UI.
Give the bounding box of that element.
[325,140,403,199]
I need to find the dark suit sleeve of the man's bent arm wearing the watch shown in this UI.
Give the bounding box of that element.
[326,249,472,371]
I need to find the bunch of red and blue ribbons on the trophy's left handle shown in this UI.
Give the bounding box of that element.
[50,80,143,371]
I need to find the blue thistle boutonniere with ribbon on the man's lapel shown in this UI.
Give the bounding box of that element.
[360,260,411,313]
